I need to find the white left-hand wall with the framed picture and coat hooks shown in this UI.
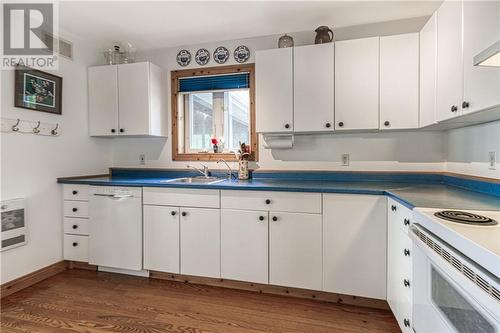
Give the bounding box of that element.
[0,31,112,283]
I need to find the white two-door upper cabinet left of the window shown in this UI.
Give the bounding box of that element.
[88,62,167,136]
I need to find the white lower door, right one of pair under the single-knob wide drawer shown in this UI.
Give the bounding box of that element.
[269,212,322,290]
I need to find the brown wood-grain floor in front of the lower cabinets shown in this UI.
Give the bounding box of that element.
[0,269,400,333]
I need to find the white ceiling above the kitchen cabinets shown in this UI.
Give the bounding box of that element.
[59,1,441,50]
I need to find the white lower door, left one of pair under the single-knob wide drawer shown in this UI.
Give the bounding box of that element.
[221,209,269,284]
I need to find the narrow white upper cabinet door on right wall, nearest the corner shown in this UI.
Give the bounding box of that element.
[419,13,437,127]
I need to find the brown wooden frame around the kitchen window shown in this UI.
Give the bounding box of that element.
[170,64,259,161]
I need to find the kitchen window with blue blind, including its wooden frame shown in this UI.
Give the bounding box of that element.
[172,64,257,160]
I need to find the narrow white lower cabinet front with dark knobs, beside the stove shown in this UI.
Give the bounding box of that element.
[387,198,413,332]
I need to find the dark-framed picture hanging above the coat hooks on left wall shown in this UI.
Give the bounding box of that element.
[14,67,62,114]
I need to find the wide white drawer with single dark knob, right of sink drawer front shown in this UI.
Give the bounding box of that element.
[221,191,321,214]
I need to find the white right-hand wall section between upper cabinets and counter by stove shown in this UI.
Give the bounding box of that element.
[446,121,500,179]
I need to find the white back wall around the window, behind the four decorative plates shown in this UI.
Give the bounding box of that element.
[113,32,446,170]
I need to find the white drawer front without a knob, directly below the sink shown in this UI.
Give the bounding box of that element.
[143,187,220,208]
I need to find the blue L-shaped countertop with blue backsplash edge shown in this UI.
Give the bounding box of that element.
[58,170,500,210]
